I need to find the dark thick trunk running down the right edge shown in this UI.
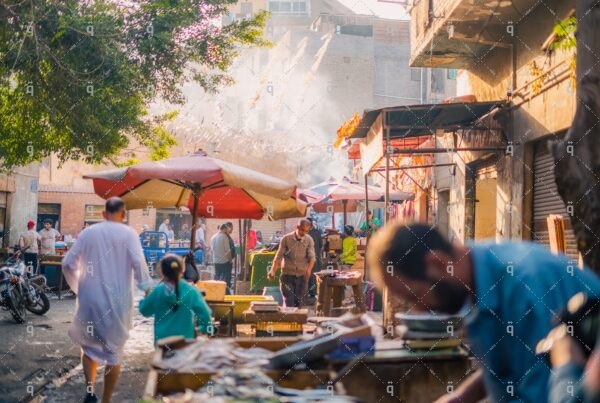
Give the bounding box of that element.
[551,0,600,274]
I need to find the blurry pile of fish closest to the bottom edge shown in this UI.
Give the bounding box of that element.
[163,368,356,403]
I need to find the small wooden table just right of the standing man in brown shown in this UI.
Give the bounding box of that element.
[315,272,366,316]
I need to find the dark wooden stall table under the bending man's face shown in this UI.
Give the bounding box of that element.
[331,340,471,403]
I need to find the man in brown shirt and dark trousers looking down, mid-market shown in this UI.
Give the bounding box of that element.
[267,219,315,308]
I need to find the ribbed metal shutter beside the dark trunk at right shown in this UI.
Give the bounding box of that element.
[532,141,579,261]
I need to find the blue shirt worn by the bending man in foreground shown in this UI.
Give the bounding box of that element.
[464,242,600,403]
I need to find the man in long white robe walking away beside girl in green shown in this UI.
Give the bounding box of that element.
[62,197,153,403]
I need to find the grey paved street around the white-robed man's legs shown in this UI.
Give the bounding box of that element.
[0,296,153,403]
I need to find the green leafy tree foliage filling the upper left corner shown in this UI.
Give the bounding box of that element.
[0,0,269,170]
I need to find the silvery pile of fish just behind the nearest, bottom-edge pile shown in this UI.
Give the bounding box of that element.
[153,339,273,372]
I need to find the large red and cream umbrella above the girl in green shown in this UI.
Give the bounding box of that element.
[84,150,306,245]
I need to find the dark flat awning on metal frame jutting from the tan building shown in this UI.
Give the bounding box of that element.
[351,101,502,139]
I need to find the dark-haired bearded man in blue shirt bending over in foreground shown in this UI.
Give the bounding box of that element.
[367,224,600,403]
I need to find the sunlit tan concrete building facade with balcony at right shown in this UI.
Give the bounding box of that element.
[411,0,577,258]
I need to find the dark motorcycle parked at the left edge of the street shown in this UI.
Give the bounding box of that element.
[0,248,50,323]
